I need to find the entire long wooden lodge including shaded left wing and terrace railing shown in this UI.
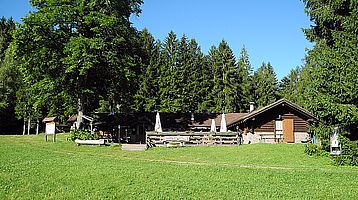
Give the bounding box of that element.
[71,99,317,146]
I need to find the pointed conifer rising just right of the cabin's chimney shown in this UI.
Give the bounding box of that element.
[253,63,278,107]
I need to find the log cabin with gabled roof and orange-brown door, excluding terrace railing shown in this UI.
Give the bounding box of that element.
[189,99,318,144]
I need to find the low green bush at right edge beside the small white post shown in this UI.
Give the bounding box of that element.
[332,136,358,166]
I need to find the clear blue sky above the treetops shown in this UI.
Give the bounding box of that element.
[0,0,312,79]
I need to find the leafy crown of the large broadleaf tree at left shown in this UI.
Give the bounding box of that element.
[14,0,142,122]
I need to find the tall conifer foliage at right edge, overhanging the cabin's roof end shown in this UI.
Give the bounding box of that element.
[300,0,358,139]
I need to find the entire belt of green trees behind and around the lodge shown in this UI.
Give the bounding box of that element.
[0,0,358,142]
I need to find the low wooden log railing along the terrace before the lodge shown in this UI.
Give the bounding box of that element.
[146,132,241,147]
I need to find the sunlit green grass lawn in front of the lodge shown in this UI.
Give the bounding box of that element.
[0,135,358,199]
